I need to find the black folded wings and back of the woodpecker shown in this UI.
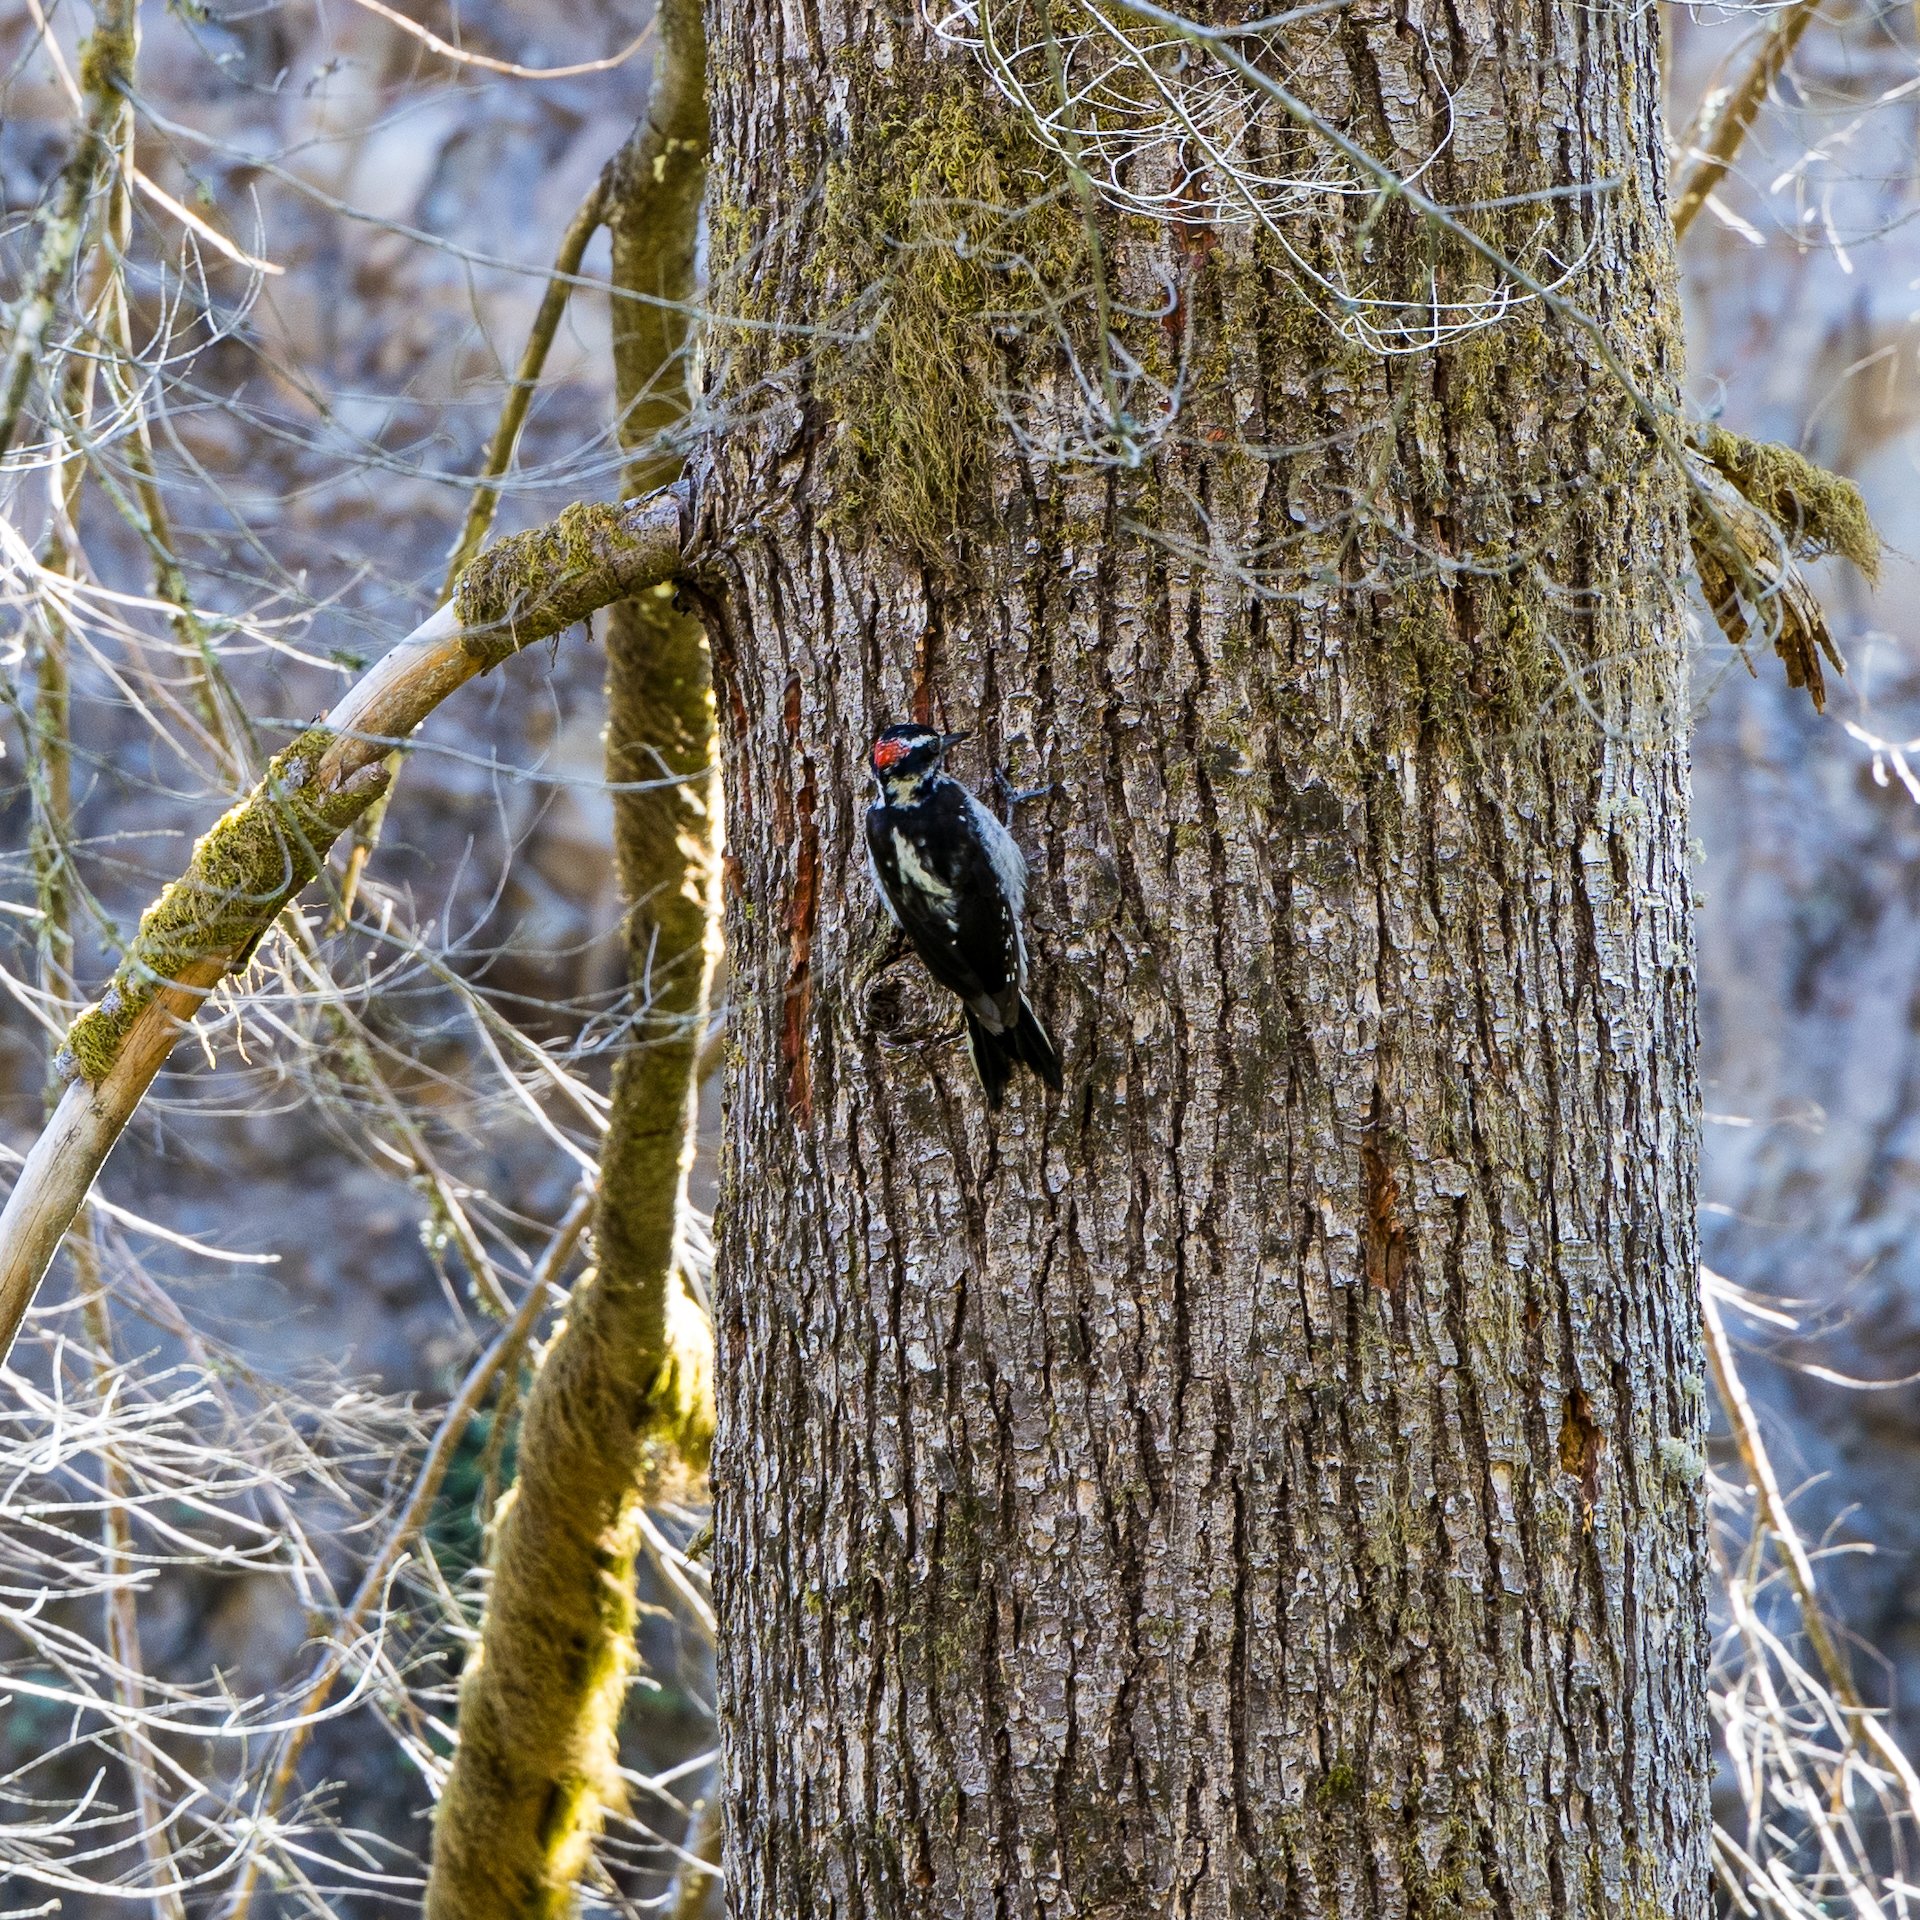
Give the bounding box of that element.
[866,785,1020,1031]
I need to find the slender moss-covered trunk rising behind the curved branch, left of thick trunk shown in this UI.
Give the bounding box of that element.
[428,0,720,1920]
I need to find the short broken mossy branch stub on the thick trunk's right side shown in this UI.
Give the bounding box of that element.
[1688,426,1880,710]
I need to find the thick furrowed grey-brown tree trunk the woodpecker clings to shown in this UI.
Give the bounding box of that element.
[699,0,1709,1920]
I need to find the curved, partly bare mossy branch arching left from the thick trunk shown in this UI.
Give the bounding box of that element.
[0,488,687,1361]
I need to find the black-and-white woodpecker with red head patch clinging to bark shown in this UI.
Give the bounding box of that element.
[866,726,1060,1110]
